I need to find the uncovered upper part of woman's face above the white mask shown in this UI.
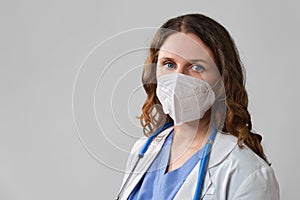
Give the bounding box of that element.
[156,32,220,86]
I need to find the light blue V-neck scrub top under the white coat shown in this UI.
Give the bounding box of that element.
[128,130,202,200]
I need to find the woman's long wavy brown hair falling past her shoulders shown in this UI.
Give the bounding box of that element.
[139,14,267,162]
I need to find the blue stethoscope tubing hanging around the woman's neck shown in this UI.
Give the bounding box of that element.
[116,121,217,200]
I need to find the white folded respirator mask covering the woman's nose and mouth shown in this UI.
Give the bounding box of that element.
[156,73,215,125]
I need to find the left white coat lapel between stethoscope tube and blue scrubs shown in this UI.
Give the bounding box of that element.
[122,127,173,199]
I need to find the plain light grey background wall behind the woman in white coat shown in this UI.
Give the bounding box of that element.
[0,0,300,200]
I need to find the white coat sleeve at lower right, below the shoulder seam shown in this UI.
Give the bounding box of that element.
[233,167,280,200]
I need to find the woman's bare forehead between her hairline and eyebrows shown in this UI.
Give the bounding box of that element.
[159,32,214,63]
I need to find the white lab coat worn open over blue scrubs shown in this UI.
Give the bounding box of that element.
[120,127,280,200]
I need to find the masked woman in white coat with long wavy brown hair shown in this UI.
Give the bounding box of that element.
[117,14,279,200]
